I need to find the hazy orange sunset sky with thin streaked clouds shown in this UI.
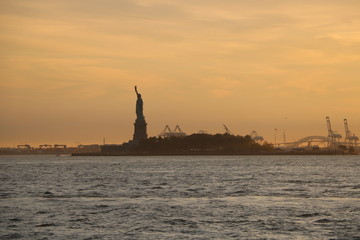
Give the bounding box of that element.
[0,0,360,147]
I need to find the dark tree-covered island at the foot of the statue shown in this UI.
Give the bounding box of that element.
[73,134,348,156]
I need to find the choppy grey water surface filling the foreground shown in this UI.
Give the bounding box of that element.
[0,156,360,239]
